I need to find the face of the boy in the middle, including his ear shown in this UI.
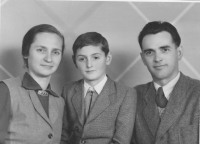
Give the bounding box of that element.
[74,45,112,86]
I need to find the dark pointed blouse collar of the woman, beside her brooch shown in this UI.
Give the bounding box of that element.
[22,72,59,97]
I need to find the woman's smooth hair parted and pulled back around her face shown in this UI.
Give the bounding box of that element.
[22,24,65,68]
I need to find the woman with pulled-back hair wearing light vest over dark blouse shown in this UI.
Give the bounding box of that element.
[0,24,64,144]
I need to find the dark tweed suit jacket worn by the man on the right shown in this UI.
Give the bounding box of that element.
[132,73,200,144]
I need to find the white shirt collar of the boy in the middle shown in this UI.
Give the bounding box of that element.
[84,75,108,97]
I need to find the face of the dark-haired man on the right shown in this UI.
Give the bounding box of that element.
[141,31,182,86]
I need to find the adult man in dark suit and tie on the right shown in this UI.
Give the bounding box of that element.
[132,21,200,144]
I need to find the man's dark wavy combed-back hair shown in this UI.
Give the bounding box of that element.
[138,21,181,49]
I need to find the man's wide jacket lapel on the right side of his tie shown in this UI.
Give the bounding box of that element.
[156,73,187,141]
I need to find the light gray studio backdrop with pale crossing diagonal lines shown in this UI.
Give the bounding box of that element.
[0,0,200,94]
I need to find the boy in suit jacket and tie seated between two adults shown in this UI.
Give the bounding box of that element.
[61,32,136,144]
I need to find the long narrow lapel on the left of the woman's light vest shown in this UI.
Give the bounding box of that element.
[28,90,52,128]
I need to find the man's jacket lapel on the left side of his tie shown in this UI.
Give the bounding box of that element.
[143,83,160,136]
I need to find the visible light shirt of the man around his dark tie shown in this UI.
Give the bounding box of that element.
[153,72,180,115]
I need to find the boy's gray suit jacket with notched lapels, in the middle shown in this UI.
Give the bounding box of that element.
[61,77,137,144]
